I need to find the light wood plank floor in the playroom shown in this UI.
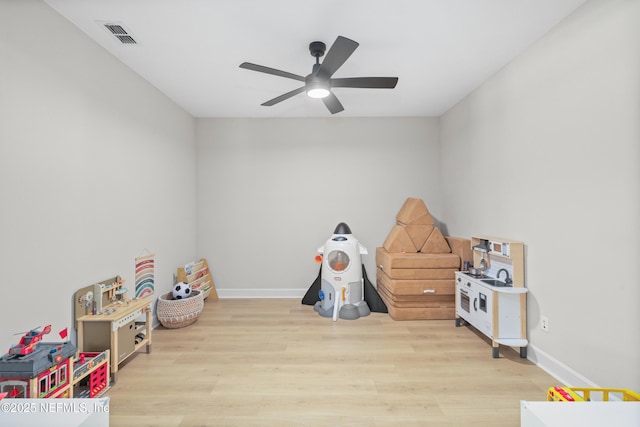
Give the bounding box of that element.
[107,299,558,427]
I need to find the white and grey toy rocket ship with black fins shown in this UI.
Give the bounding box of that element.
[302,222,387,321]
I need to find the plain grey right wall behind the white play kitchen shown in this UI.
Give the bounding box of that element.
[440,0,640,390]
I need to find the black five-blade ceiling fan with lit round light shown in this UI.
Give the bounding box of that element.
[240,36,398,114]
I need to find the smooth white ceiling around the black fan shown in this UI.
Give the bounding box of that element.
[45,0,585,117]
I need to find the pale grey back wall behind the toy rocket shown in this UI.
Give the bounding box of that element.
[196,118,442,296]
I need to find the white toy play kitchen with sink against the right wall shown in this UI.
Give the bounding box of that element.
[456,237,528,358]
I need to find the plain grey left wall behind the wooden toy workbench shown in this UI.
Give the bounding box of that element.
[0,0,196,353]
